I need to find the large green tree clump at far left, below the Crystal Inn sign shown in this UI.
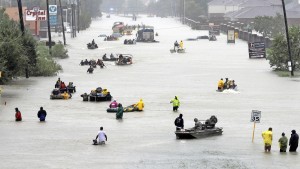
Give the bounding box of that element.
[0,9,62,83]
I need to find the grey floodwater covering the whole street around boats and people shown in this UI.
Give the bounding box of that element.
[0,16,300,169]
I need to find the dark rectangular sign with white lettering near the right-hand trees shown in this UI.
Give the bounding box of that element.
[248,42,266,59]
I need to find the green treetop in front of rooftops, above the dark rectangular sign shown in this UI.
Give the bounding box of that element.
[254,14,284,37]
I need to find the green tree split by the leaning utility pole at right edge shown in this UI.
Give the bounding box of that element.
[267,27,300,71]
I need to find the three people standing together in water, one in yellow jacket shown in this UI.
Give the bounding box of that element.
[262,127,299,152]
